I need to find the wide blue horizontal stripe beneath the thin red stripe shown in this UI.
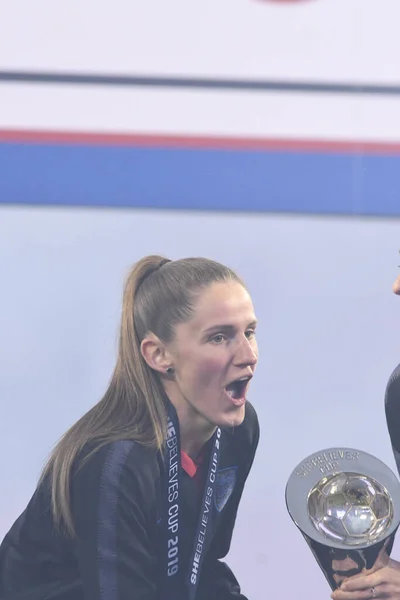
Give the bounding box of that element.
[0,142,400,216]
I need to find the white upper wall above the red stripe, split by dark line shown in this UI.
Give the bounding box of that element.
[0,0,400,142]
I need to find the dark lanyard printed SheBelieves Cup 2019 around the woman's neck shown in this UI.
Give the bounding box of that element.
[160,406,221,600]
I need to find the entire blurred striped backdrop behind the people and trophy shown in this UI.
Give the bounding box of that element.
[0,0,400,600]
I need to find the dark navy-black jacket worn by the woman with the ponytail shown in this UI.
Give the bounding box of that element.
[0,403,259,600]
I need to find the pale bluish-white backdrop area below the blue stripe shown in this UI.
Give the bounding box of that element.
[0,207,400,600]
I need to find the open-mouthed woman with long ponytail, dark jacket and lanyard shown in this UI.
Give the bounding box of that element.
[0,256,259,600]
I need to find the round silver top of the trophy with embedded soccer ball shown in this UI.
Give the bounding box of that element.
[286,448,400,548]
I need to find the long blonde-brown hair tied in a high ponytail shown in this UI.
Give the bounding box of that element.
[40,255,244,536]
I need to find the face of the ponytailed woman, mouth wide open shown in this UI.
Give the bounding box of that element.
[166,282,258,427]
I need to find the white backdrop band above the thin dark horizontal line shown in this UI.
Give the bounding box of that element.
[0,0,400,83]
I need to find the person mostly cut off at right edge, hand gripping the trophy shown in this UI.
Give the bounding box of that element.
[331,276,400,600]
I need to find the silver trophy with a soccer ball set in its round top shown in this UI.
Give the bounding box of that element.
[286,448,400,590]
